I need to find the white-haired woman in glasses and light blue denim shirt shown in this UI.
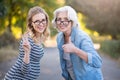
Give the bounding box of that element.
[52,6,103,80]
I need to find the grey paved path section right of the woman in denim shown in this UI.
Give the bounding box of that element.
[101,55,120,80]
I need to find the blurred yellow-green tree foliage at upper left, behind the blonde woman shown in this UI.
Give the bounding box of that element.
[0,0,63,33]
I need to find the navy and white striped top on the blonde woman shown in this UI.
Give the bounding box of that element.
[4,38,44,80]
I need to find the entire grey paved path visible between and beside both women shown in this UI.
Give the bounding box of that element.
[0,48,120,80]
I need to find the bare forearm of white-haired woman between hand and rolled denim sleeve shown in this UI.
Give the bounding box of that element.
[74,47,88,63]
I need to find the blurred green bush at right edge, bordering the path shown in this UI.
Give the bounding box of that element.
[100,40,120,58]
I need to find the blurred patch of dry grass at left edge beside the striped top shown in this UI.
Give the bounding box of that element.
[0,46,18,62]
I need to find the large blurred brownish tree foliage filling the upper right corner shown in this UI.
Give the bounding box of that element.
[66,0,120,39]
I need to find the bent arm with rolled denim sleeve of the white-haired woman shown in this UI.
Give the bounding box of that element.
[76,37,102,68]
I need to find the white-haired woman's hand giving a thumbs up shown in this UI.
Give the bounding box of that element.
[62,37,76,53]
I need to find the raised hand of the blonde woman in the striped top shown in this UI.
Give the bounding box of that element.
[22,34,31,53]
